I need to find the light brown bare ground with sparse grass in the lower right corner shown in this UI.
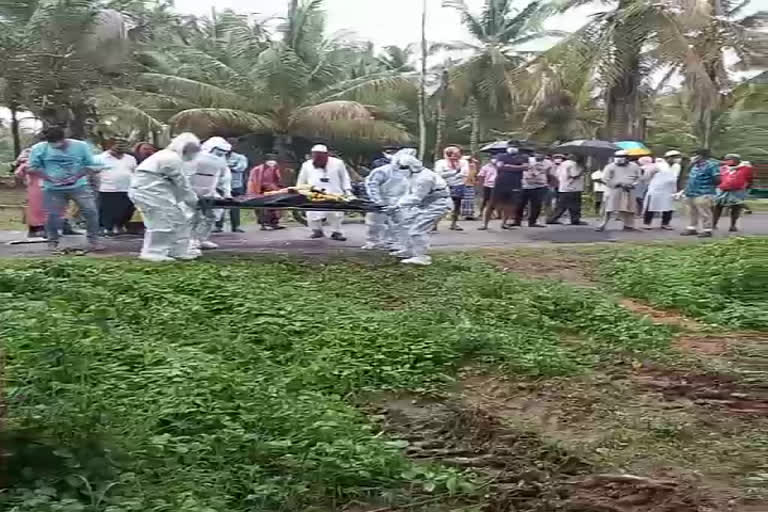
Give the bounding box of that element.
[458,367,768,512]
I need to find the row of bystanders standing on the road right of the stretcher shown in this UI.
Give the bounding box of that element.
[416,146,753,237]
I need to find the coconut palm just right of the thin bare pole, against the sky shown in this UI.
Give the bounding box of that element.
[440,0,563,153]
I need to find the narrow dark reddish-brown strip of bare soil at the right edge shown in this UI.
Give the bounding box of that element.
[633,370,768,416]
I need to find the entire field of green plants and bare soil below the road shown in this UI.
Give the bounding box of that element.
[0,240,768,512]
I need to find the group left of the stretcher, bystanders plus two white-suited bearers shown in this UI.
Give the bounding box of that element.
[15,127,288,261]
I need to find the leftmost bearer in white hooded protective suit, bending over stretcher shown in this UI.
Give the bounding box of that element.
[128,133,200,262]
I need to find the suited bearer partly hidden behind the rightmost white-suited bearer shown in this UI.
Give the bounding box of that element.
[363,148,416,250]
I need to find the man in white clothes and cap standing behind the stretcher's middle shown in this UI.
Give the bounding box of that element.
[296,144,352,242]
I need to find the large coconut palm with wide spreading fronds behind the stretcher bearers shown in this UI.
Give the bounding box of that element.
[111,0,410,152]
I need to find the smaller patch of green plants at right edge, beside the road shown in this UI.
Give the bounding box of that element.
[601,238,768,330]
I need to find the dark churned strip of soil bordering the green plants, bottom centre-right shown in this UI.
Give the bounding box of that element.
[372,398,725,512]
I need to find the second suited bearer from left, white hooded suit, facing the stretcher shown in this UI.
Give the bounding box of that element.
[188,137,232,251]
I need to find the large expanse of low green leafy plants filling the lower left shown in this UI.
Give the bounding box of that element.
[0,257,669,512]
